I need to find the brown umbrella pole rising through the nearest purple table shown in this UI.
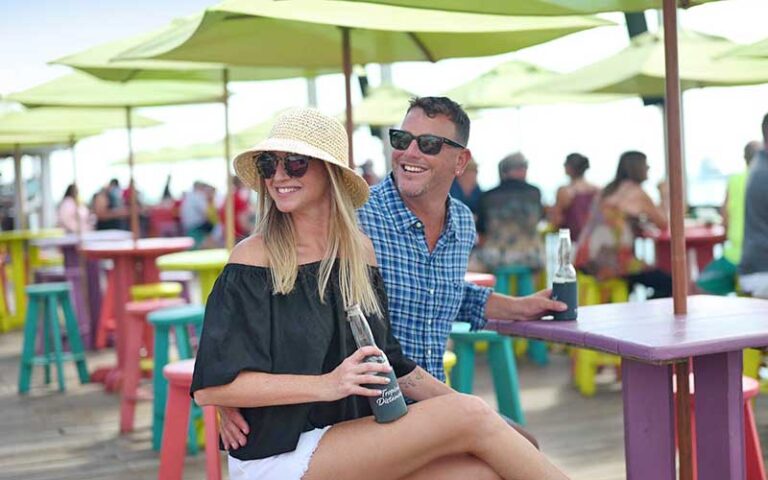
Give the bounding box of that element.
[664,0,694,480]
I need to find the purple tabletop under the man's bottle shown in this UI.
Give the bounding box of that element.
[485,295,768,363]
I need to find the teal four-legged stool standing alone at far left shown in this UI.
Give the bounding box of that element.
[19,282,88,394]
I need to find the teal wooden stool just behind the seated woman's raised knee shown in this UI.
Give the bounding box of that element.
[451,322,525,425]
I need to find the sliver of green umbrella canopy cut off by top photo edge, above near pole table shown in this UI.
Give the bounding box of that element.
[342,0,716,15]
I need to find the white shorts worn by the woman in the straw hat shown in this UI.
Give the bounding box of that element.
[228,426,331,480]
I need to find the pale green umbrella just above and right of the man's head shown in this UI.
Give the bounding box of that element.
[445,60,629,109]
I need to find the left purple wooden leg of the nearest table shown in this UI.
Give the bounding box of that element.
[621,359,676,480]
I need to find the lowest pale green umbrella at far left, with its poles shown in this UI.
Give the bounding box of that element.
[0,108,159,229]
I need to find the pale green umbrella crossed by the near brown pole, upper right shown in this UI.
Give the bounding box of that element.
[531,30,768,96]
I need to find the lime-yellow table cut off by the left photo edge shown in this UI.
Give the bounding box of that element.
[0,228,64,332]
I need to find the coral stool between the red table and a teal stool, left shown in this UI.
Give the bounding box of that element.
[120,298,184,433]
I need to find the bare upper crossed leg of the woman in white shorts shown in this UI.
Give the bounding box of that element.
[304,394,567,480]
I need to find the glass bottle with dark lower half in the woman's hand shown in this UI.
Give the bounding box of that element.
[347,304,408,423]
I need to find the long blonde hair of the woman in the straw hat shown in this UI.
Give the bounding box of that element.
[256,160,381,315]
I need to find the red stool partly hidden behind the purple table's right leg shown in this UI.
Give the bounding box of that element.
[673,376,765,480]
